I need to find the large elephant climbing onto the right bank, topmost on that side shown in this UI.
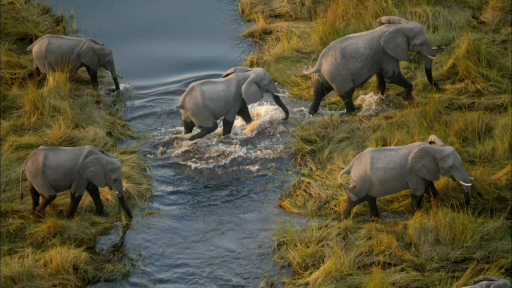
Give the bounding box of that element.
[303,16,439,115]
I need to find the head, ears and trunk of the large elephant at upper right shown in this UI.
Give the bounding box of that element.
[378,16,439,89]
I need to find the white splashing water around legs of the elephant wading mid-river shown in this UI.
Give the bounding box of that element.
[155,102,286,171]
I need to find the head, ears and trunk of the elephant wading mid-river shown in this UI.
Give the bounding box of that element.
[222,67,290,120]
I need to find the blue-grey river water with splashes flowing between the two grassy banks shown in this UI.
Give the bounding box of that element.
[43,0,306,287]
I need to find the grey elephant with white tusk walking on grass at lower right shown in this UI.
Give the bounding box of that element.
[338,136,473,218]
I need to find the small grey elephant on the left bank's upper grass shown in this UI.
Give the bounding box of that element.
[27,34,120,91]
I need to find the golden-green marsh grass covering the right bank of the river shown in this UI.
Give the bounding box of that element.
[240,0,512,287]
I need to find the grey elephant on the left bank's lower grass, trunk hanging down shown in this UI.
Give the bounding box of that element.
[20,145,132,218]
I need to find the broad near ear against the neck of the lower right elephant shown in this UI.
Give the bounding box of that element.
[409,145,441,181]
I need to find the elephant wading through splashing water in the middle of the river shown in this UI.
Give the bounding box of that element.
[176,67,290,141]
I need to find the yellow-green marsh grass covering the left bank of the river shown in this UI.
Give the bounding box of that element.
[1,0,151,287]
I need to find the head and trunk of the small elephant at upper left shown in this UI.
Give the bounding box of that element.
[78,39,120,91]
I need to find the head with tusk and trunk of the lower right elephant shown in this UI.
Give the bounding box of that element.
[409,145,473,205]
